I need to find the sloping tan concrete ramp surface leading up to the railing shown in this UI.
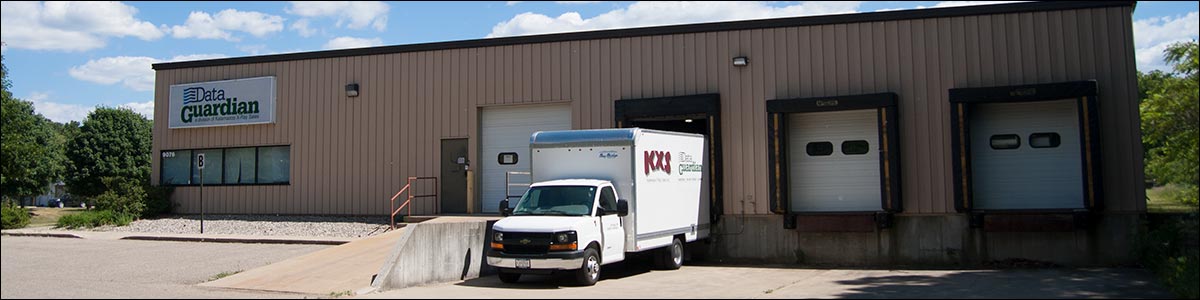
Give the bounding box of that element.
[200,227,408,295]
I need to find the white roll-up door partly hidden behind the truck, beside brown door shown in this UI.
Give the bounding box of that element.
[478,104,571,212]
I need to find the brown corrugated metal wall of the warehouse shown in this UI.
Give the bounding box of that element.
[154,7,1145,215]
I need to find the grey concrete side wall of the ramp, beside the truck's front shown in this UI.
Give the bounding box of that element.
[364,217,499,292]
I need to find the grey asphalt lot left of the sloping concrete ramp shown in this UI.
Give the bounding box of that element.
[0,236,329,299]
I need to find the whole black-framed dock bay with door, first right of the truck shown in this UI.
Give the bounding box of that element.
[767,92,902,232]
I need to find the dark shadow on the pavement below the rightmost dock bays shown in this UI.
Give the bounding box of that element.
[835,269,1172,299]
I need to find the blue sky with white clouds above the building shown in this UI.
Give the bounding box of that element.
[0,1,1200,122]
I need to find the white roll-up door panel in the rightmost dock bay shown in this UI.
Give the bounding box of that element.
[971,100,1084,210]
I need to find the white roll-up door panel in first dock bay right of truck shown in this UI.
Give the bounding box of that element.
[787,109,882,212]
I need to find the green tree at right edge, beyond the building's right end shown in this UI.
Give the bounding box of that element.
[1138,41,1200,203]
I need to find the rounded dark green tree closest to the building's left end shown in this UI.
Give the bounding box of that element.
[66,107,151,197]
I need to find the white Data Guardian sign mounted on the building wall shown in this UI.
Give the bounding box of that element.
[168,77,275,128]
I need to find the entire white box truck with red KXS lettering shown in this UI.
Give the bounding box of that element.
[487,128,709,286]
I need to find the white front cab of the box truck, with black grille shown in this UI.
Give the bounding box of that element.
[488,179,629,284]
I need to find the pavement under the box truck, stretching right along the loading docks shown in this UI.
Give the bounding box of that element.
[362,255,1171,299]
